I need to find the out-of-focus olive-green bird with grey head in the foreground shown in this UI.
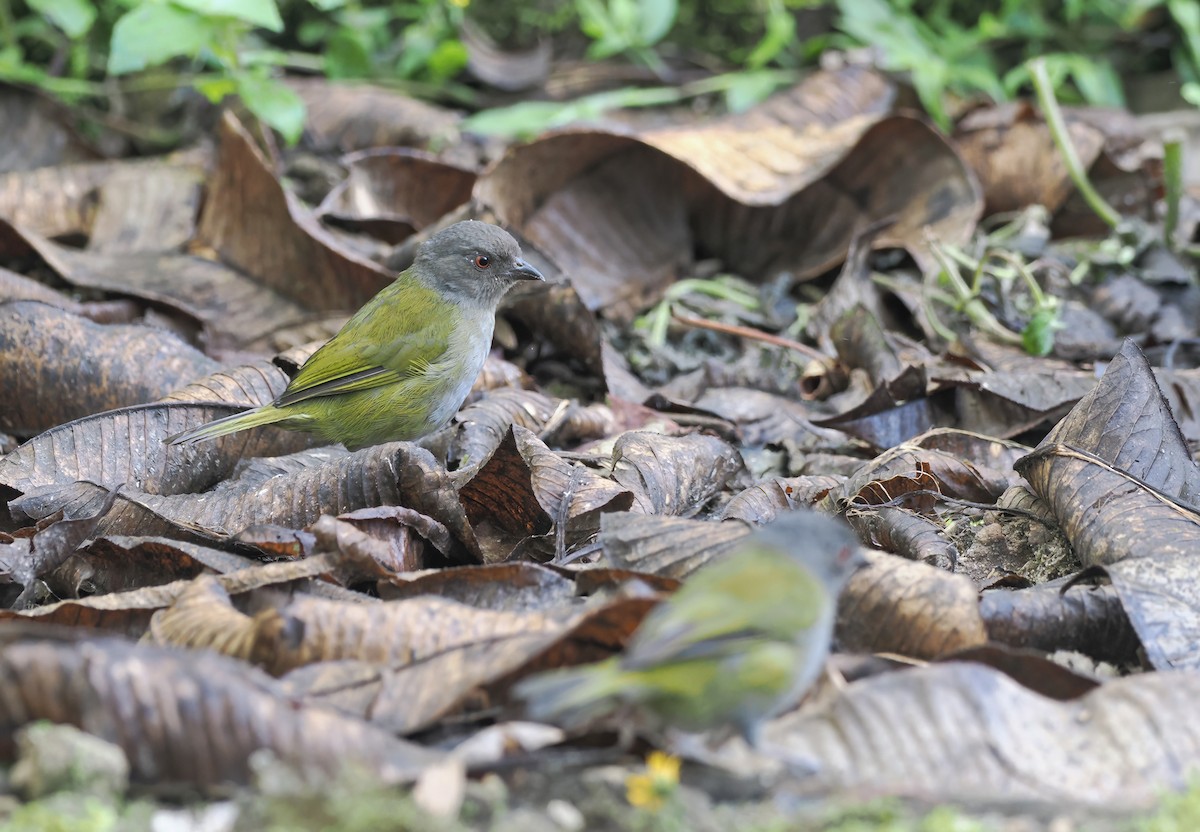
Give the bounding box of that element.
[515,510,865,746]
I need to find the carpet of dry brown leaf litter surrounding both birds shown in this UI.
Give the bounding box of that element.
[0,58,1200,825]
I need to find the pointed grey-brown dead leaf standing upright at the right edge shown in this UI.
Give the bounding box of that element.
[1018,341,1200,668]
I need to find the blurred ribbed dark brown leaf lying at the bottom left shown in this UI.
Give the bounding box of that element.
[0,639,438,788]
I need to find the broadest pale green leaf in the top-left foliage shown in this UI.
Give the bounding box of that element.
[108,4,216,76]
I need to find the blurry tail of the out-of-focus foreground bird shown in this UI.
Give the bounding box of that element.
[514,658,629,725]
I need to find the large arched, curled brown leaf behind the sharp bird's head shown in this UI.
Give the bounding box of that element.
[476,68,980,318]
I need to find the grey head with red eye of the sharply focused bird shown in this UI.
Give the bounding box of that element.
[413,220,522,307]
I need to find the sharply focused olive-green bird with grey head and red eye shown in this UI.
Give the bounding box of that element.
[167,220,544,450]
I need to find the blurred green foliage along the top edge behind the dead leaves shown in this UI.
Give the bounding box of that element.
[7,0,1200,147]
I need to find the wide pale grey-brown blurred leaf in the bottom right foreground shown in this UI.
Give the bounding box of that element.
[766,663,1200,813]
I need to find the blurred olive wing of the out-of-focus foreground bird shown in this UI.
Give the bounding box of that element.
[622,552,830,669]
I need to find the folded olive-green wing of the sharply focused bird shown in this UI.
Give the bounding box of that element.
[275,280,448,407]
